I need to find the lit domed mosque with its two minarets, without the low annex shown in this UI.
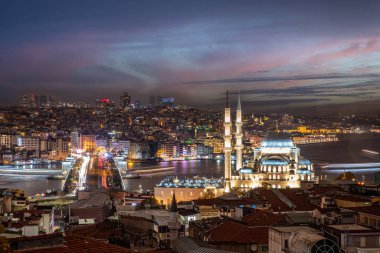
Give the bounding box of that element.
[224,91,314,193]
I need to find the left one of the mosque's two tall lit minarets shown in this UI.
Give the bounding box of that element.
[224,90,232,193]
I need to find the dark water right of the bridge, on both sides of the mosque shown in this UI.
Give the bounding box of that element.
[124,134,380,190]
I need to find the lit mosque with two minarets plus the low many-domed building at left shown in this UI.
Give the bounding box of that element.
[154,91,314,205]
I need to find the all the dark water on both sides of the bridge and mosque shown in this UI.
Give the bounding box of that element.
[0,134,380,195]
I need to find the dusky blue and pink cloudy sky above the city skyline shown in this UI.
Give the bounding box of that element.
[0,0,380,111]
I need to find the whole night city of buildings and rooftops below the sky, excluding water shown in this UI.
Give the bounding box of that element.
[0,93,380,252]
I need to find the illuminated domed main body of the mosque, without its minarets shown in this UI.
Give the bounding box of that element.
[231,135,314,189]
